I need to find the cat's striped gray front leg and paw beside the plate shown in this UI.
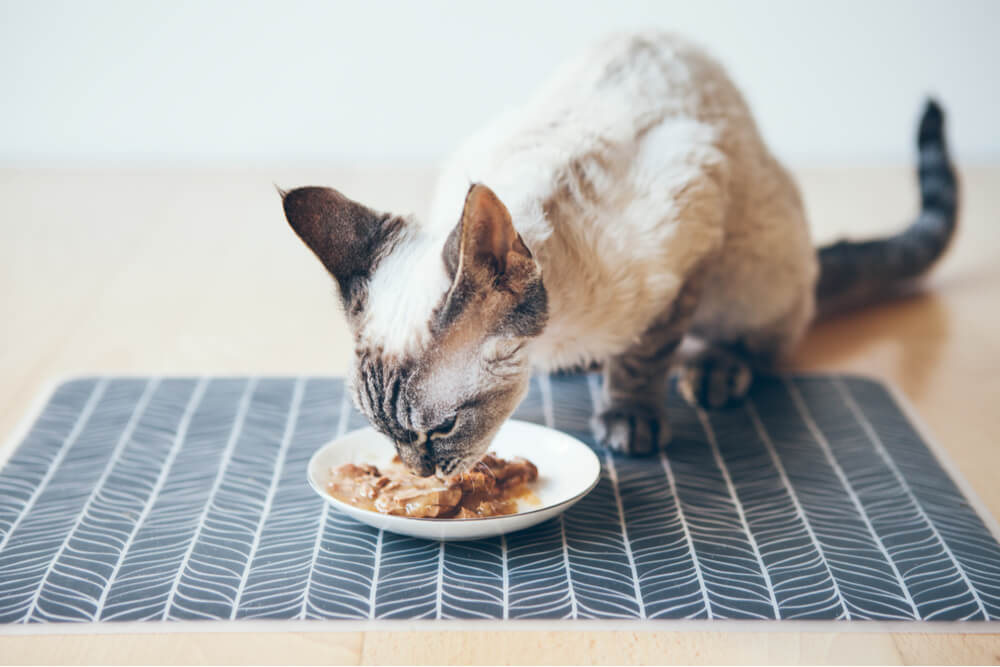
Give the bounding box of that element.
[593,280,700,455]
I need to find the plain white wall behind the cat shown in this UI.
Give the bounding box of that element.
[0,0,1000,164]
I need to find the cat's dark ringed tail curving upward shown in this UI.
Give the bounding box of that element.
[816,100,958,316]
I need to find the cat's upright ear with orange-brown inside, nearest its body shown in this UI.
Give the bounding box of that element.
[444,184,534,287]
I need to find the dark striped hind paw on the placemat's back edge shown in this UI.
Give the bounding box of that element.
[677,348,753,408]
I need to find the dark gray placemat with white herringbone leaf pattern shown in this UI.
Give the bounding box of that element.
[0,375,1000,624]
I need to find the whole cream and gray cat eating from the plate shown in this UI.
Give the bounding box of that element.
[281,32,958,476]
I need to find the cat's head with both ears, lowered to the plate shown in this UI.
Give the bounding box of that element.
[282,185,548,476]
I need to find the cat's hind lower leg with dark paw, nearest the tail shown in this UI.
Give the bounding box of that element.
[677,298,812,408]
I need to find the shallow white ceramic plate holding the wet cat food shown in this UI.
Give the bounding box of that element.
[308,420,601,540]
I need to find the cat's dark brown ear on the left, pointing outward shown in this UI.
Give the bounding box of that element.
[278,187,403,305]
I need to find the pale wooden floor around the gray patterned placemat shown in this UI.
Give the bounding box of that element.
[0,168,1000,664]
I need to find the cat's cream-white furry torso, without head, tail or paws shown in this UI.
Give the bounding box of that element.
[406,33,817,367]
